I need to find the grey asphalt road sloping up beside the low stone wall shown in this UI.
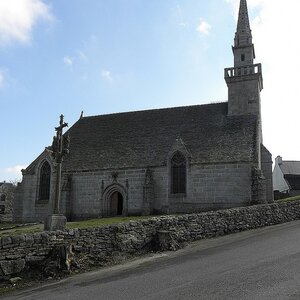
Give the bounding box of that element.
[3,221,300,300]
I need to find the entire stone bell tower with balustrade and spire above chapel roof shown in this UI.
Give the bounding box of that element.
[225,0,263,116]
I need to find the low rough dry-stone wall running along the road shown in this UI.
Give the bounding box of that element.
[0,201,300,280]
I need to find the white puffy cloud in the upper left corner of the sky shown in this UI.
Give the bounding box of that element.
[0,0,54,45]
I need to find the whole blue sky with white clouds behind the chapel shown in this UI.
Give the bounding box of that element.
[0,0,300,181]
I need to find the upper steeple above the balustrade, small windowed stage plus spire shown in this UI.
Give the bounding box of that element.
[232,0,255,67]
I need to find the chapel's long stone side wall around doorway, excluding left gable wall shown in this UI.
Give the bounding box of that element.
[62,163,251,220]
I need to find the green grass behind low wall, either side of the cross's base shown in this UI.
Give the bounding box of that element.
[0,216,154,237]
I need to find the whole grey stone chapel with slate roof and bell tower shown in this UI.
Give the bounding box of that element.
[15,0,273,222]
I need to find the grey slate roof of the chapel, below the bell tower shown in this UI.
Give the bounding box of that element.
[57,102,257,171]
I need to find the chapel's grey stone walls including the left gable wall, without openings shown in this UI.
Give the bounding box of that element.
[15,156,252,222]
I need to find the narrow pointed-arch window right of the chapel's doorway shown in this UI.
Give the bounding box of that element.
[171,151,186,194]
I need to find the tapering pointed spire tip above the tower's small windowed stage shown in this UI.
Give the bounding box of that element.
[234,0,252,47]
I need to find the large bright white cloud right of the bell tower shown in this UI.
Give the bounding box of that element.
[226,0,300,160]
